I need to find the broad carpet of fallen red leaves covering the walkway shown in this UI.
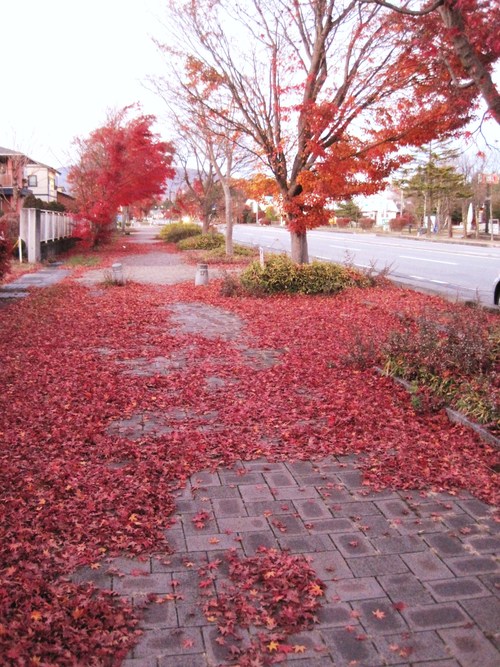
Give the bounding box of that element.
[0,256,499,666]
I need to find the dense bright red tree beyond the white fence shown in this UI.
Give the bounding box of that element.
[68,107,175,237]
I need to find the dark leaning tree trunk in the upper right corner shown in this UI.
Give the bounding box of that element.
[437,4,500,124]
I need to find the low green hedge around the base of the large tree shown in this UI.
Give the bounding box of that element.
[241,255,370,294]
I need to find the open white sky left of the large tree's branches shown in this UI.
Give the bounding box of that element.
[0,0,168,168]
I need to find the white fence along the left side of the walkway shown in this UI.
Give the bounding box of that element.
[19,208,75,262]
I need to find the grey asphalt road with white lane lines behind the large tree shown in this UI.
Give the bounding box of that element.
[234,225,500,305]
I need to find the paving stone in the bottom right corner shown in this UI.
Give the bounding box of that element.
[438,628,500,667]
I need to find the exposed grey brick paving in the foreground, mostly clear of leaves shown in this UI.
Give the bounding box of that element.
[71,457,500,667]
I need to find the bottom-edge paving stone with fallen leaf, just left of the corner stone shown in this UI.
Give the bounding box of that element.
[374,631,450,667]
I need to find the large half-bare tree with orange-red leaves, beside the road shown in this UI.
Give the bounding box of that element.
[161,0,474,262]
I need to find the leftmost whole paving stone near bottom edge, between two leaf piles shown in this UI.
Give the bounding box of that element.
[134,627,204,660]
